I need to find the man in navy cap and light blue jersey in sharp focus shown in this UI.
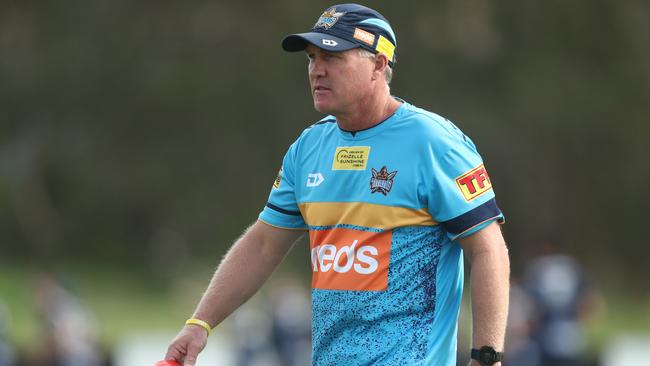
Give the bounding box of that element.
[166,4,509,366]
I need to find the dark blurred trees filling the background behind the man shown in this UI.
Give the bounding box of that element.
[0,0,650,285]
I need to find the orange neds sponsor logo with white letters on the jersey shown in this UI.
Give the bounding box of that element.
[309,228,393,291]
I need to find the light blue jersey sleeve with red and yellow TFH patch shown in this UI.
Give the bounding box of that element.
[428,122,505,240]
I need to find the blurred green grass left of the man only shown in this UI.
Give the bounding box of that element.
[0,264,209,348]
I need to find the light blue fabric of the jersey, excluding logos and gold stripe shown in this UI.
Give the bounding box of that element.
[260,98,494,366]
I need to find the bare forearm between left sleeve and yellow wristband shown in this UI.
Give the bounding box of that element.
[187,221,302,327]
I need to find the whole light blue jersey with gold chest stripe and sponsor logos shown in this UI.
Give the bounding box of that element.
[260,103,503,366]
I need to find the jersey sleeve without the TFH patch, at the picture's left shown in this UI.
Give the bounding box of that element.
[259,143,307,229]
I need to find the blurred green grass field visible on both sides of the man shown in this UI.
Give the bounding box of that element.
[0,263,650,358]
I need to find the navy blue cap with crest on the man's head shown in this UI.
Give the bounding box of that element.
[282,4,397,67]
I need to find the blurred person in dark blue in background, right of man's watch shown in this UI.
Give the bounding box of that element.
[506,242,602,366]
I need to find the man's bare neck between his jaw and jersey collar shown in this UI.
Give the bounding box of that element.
[336,93,401,131]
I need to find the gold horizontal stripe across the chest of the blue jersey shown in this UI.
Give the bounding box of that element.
[299,202,438,230]
